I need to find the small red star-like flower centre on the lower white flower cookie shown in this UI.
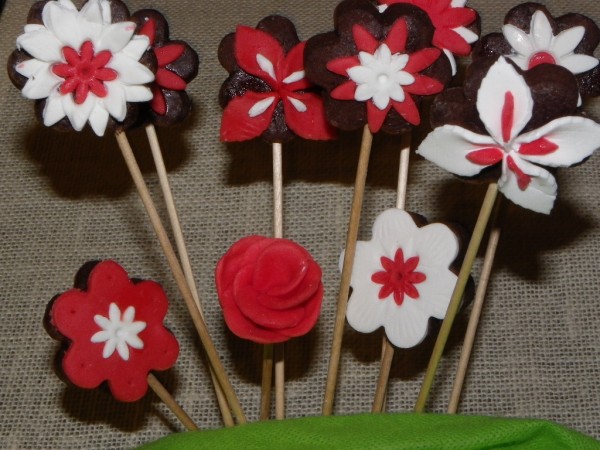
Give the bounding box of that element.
[371,248,427,306]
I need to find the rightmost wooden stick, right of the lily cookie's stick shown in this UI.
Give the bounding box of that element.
[448,197,502,414]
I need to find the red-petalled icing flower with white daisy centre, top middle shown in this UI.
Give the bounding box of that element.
[327,19,444,133]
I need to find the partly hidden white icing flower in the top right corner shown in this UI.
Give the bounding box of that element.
[502,10,599,74]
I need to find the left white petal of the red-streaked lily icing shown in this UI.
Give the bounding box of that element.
[417,125,496,177]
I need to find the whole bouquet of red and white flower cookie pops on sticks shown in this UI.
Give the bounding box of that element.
[8,0,600,448]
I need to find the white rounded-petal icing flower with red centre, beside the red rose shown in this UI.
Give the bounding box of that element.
[340,209,459,348]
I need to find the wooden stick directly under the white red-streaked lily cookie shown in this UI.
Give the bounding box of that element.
[415,183,498,412]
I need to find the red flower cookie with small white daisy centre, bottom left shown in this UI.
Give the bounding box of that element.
[46,261,179,402]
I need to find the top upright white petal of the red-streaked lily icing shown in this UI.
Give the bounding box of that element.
[477,58,533,143]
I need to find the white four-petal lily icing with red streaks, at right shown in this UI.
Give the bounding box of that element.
[417,58,600,214]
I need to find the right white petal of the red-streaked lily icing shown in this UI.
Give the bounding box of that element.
[515,116,600,167]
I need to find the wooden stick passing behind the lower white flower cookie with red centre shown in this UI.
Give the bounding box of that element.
[371,133,411,413]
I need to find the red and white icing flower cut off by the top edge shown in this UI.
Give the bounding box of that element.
[379,0,479,75]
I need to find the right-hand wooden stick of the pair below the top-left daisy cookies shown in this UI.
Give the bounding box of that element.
[146,124,234,427]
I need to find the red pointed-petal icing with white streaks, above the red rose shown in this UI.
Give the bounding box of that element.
[221,22,335,142]
